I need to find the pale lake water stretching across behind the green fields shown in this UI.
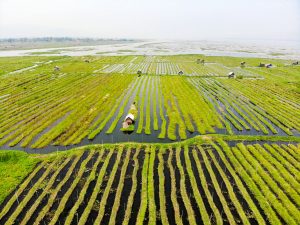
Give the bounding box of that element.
[0,40,300,60]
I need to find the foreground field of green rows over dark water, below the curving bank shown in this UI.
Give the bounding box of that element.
[0,137,300,224]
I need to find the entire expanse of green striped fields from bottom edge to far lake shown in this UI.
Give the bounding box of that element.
[0,55,300,225]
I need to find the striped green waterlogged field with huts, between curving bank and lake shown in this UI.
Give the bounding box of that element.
[0,55,300,148]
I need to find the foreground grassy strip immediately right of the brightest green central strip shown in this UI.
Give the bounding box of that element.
[157,148,169,225]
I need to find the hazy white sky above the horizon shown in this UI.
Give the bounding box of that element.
[0,0,300,40]
